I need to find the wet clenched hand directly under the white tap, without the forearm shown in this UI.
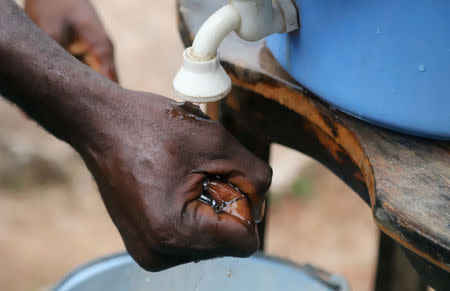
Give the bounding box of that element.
[74,90,272,271]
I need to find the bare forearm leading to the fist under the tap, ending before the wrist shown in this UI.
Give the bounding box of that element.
[0,0,121,144]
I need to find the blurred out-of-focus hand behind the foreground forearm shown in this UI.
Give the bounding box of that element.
[25,0,117,82]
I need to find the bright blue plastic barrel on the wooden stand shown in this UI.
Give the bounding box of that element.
[267,0,450,140]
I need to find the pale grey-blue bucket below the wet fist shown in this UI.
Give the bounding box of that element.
[54,253,350,291]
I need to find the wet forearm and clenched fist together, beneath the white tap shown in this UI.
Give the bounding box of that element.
[0,0,272,271]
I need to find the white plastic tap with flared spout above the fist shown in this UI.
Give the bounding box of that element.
[173,0,299,103]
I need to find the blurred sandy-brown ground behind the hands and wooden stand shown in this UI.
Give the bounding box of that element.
[0,0,378,291]
